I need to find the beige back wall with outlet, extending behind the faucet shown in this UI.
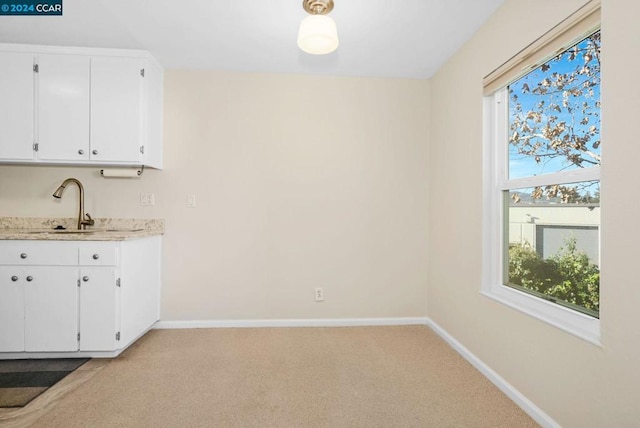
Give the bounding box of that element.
[0,70,429,320]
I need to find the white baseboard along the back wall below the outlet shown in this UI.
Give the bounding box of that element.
[153,317,427,329]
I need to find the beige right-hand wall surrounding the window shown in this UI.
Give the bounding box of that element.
[427,0,640,427]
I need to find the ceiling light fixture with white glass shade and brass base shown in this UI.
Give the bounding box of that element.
[298,0,338,55]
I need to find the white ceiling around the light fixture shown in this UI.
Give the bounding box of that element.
[0,0,504,78]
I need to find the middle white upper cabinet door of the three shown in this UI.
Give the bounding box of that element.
[37,55,90,161]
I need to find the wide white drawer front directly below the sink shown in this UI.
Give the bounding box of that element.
[0,241,78,266]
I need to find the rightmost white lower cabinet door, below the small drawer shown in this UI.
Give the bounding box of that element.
[80,268,120,351]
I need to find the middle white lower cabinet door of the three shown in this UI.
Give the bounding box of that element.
[24,266,78,352]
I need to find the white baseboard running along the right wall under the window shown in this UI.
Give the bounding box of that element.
[426,318,560,428]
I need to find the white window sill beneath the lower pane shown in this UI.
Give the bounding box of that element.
[481,285,602,346]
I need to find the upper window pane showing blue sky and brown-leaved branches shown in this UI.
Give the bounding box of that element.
[508,31,601,178]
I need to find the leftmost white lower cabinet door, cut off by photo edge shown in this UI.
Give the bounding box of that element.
[0,266,25,352]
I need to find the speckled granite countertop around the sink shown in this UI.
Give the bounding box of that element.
[0,217,164,241]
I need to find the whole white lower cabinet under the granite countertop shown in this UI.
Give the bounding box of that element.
[0,236,161,359]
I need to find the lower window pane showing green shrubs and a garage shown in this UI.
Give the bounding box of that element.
[504,181,600,317]
